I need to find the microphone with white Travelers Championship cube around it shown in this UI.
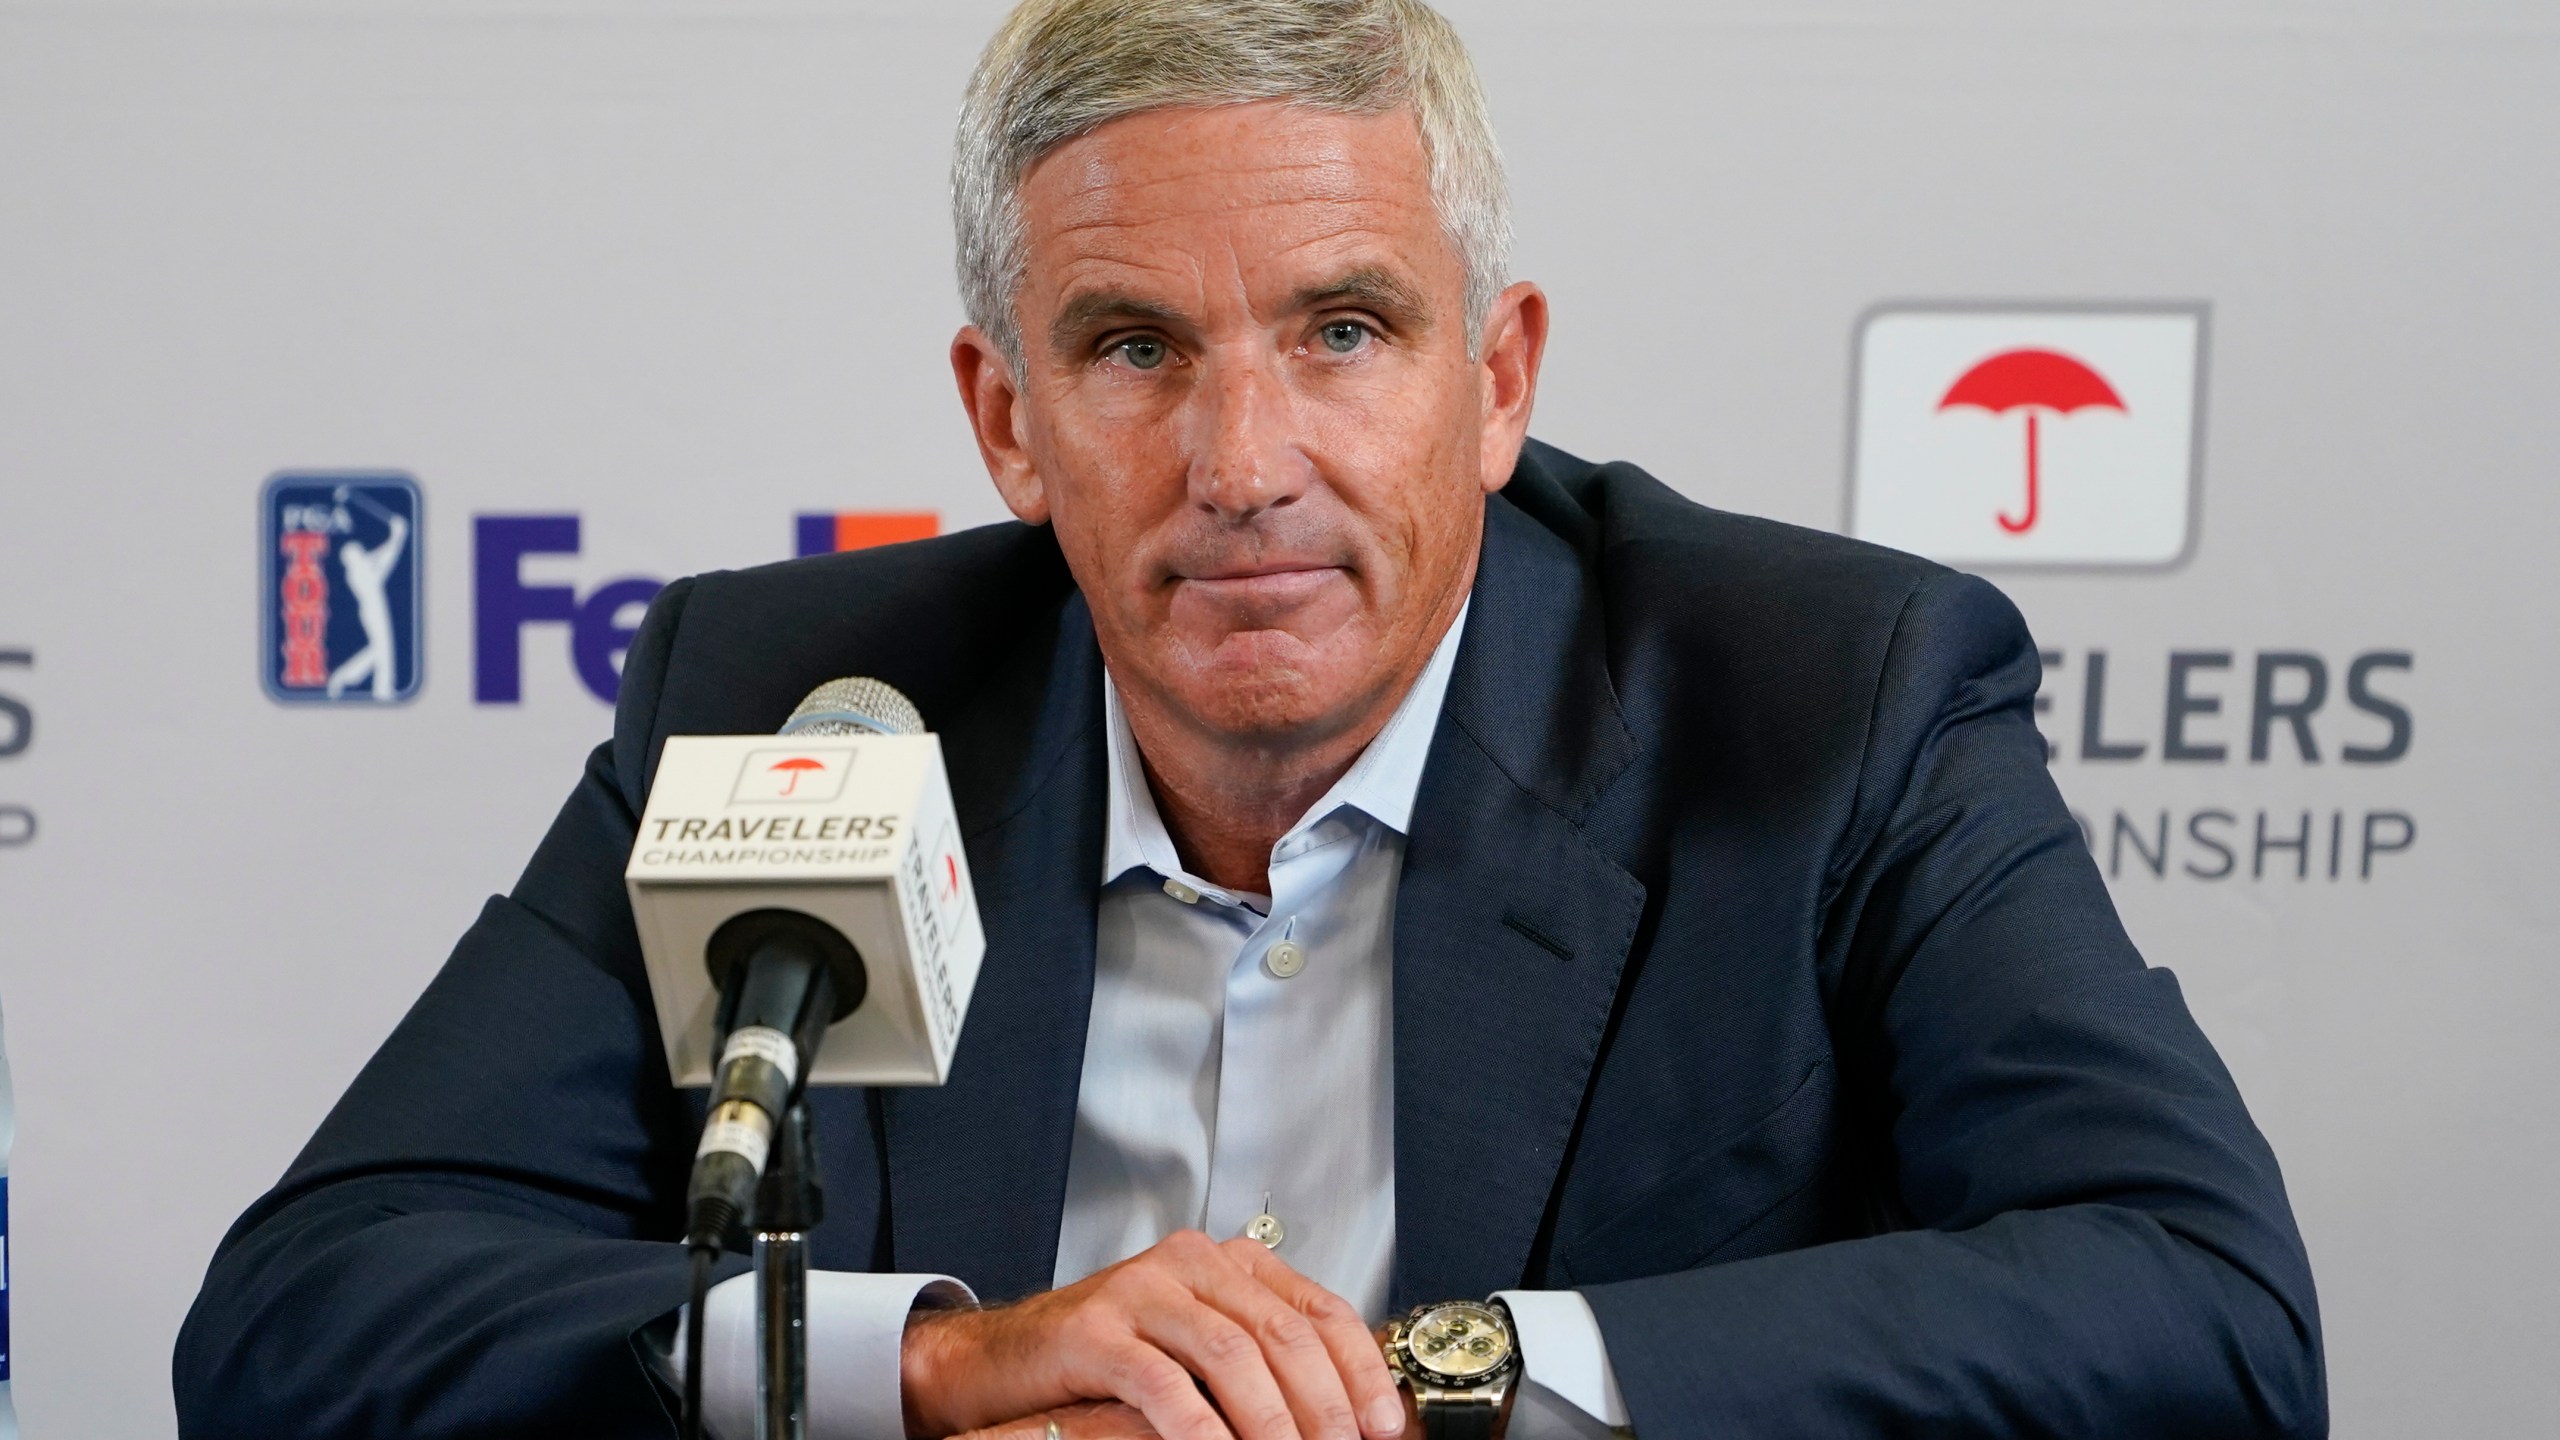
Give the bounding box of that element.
[625,679,986,1250]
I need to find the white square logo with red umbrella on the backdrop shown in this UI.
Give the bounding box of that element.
[1848,305,2204,569]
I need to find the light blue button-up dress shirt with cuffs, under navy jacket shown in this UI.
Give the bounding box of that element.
[676,597,1626,1440]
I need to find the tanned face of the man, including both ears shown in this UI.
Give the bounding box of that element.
[952,105,1544,743]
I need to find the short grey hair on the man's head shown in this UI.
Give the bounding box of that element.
[952,0,1510,374]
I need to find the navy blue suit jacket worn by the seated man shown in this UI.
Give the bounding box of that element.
[177,446,2327,1440]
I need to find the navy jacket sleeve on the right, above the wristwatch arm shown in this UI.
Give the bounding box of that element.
[1587,574,2327,1440]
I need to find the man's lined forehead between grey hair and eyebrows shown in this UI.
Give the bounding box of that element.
[1021,102,1454,295]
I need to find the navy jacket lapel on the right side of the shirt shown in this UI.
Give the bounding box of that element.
[1393,484,1646,1307]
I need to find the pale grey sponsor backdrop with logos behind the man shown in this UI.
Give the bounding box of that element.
[0,0,2560,1440]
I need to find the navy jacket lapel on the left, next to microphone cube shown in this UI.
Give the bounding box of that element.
[881,592,1103,1299]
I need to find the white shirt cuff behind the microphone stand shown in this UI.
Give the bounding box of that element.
[668,1271,978,1440]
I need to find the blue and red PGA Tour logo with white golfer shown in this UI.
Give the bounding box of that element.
[259,471,425,705]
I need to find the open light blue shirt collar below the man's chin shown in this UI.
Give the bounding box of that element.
[1103,597,1475,889]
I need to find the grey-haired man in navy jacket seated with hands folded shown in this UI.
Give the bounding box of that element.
[177,0,2327,1440]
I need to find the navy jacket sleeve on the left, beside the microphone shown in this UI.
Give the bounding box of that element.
[174,582,735,1440]
